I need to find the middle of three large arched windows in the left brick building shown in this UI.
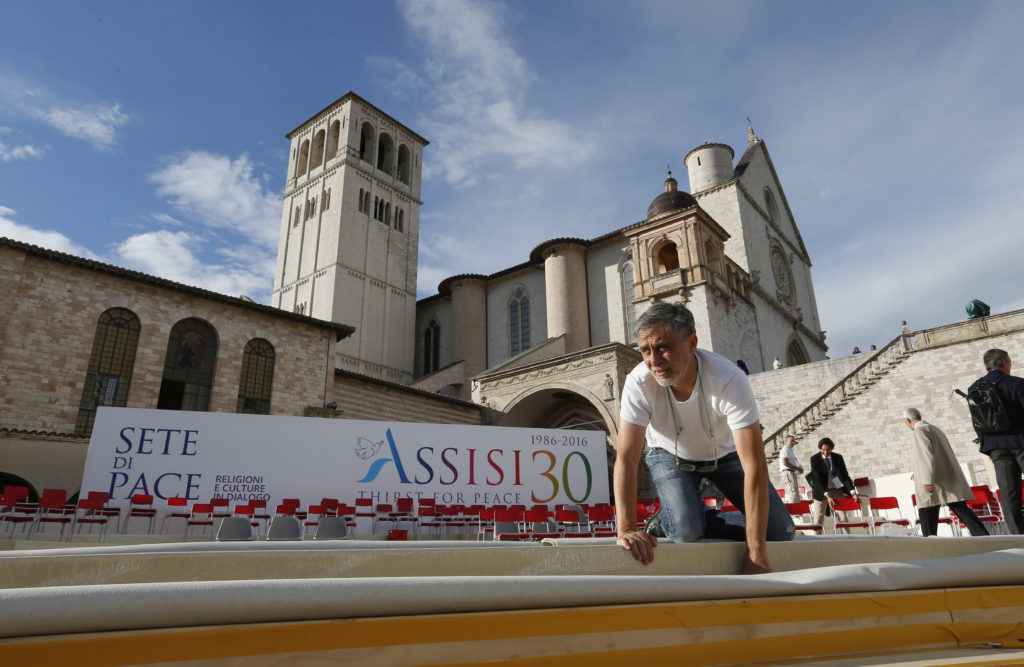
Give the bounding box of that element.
[157,318,217,412]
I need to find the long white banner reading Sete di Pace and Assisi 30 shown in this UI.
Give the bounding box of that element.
[82,407,608,507]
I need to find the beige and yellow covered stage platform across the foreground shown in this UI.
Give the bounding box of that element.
[0,536,1024,667]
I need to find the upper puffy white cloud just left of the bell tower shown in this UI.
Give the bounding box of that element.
[148,151,281,248]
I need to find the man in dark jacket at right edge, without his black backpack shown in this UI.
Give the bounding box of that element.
[971,349,1024,535]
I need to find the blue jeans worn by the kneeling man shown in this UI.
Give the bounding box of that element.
[646,447,796,542]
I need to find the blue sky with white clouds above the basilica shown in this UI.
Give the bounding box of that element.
[0,0,1024,357]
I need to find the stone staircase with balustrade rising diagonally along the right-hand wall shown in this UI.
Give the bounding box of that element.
[765,334,913,460]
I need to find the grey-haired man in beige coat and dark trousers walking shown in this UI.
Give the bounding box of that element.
[903,408,988,537]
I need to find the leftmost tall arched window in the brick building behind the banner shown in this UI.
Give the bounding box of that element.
[75,308,141,435]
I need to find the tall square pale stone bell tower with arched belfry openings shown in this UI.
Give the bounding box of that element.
[271,92,428,383]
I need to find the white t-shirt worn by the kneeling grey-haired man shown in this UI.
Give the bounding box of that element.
[618,348,758,461]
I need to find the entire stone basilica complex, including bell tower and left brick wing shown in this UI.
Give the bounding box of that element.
[0,92,826,497]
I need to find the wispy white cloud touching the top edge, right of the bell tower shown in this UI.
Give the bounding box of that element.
[393,0,594,185]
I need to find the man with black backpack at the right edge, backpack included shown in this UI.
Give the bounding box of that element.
[967,349,1024,535]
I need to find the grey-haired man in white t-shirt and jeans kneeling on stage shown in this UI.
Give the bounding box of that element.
[614,302,795,574]
